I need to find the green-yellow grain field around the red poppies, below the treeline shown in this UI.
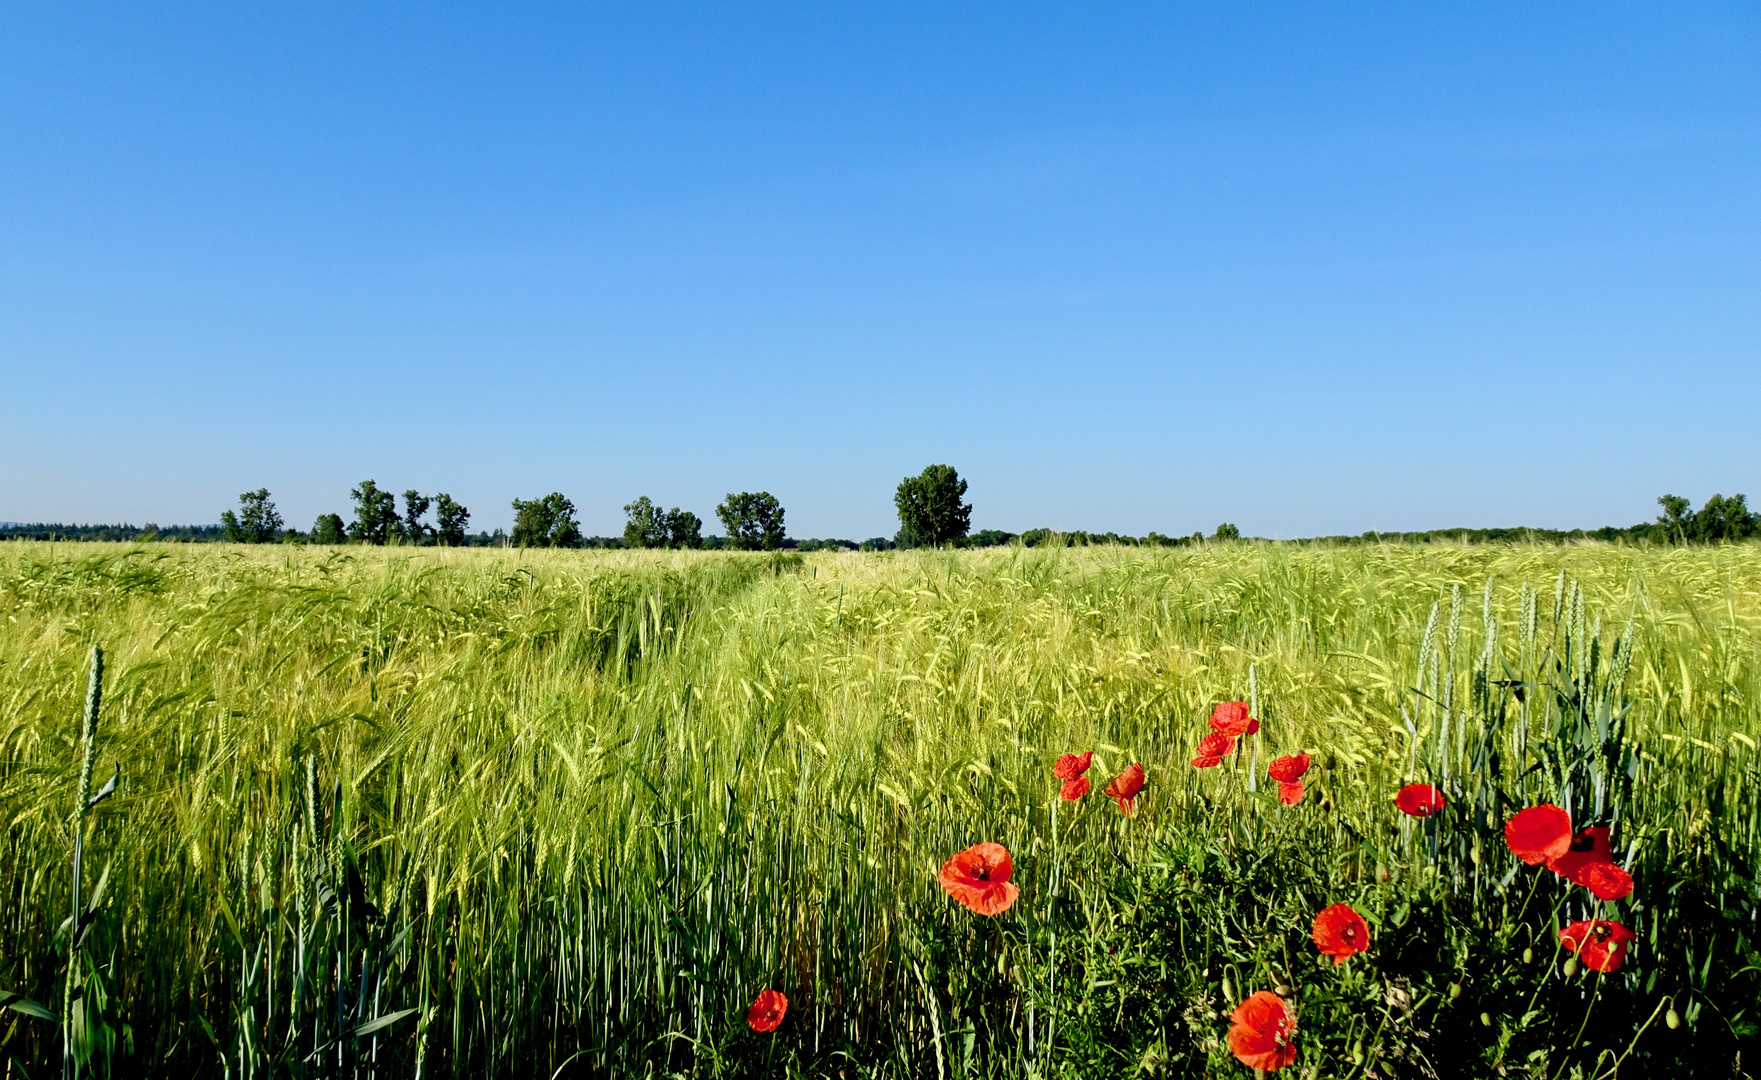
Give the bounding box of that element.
[0,543,1761,1076]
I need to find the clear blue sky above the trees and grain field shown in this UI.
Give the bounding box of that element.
[0,2,1761,539]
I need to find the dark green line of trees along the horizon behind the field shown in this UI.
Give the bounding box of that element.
[0,479,1761,551]
